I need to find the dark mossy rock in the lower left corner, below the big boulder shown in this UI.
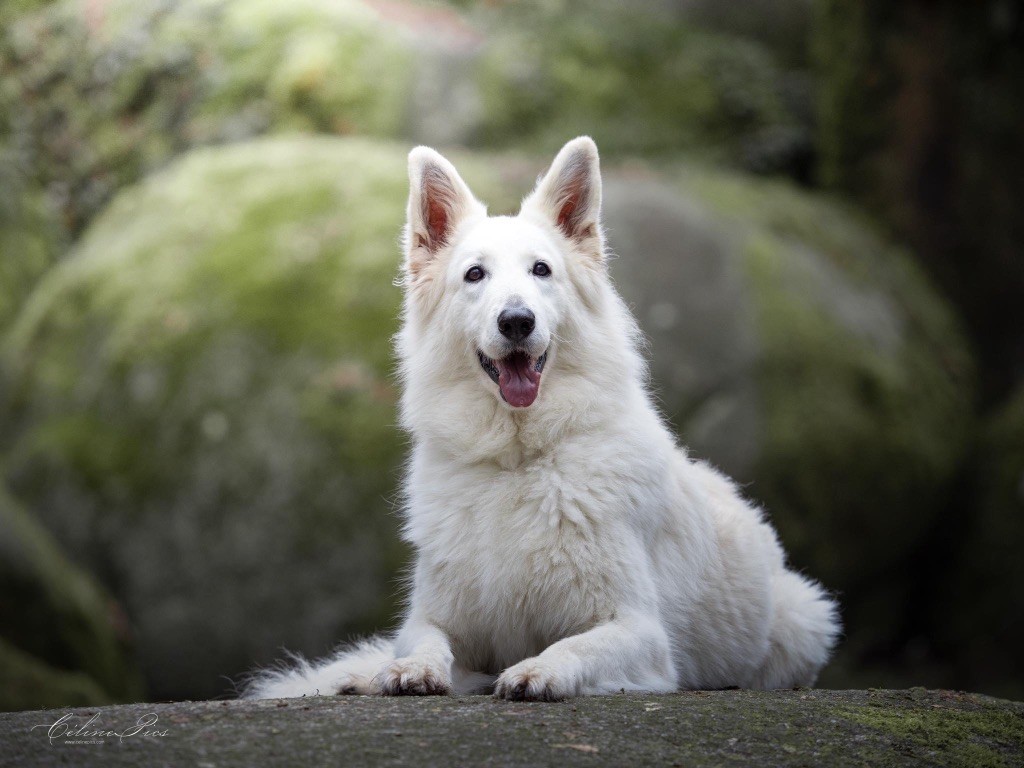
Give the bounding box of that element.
[0,488,142,711]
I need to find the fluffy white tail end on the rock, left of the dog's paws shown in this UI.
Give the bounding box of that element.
[242,637,394,698]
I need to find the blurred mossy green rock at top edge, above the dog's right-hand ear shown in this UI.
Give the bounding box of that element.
[478,0,812,175]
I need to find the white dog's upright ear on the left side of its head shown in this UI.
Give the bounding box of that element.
[404,146,487,279]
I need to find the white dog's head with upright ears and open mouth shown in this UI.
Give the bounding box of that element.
[404,136,605,409]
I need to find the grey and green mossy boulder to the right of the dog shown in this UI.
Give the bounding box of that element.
[606,165,973,684]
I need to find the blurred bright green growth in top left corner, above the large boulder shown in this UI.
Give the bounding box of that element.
[0,0,412,233]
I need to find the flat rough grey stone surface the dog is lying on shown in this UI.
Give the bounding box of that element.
[0,688,1024,768]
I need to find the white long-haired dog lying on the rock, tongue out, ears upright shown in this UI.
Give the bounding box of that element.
[248,137,840,700]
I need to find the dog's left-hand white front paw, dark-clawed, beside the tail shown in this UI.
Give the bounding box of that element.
[378,617,454,696]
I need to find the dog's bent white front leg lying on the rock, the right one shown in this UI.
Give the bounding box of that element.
[495,613,676,701]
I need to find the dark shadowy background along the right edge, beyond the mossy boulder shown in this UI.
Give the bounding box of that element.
[812,0,1024,697]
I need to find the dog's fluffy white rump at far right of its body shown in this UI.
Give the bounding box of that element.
[752,568,841,689]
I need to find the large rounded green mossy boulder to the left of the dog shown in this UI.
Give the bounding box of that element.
[7,137,536,697]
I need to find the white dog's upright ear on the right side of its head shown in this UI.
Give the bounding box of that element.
[521,136,604,261]
